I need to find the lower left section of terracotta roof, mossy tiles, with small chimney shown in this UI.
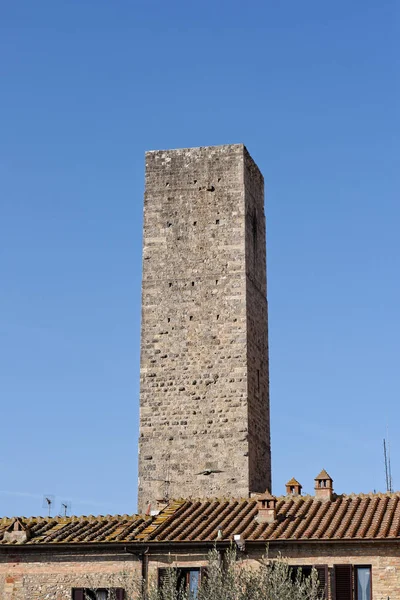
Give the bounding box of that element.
[0,515,152,545]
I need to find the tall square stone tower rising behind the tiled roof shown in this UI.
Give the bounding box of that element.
[139,144,271,512]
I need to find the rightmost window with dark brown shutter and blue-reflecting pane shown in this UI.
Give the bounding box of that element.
[334,565,372,600]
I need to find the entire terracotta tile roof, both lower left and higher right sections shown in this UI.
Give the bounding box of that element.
[0,492,400,547]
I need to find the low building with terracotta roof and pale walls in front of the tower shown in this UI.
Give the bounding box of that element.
[0,478,400,600]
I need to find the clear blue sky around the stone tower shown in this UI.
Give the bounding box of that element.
[0,0,400,515]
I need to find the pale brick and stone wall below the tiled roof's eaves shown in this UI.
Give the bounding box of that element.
[0,542,400,600]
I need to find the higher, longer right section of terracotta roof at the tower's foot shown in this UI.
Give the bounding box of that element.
[137,492,400,542]
